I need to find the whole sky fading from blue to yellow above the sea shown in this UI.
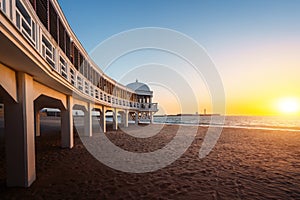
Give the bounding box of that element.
[59,0,300,116]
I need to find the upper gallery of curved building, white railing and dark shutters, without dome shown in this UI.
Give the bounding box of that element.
[0,0,141,109]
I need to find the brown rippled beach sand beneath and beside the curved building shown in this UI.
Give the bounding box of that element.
[0,117,300,199]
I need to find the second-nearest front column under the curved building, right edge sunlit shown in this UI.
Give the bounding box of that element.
[61,96,74,148]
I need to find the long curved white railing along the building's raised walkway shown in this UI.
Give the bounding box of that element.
[0,0,144,109]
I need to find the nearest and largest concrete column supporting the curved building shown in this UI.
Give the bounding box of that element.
[4,73,36,187]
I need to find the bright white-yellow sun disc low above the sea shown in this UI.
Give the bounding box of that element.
[277,98,300,114]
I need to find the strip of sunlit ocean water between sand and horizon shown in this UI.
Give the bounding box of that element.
[154,116,300,131]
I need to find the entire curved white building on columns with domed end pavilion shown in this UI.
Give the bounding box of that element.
[0,0,158,187]
